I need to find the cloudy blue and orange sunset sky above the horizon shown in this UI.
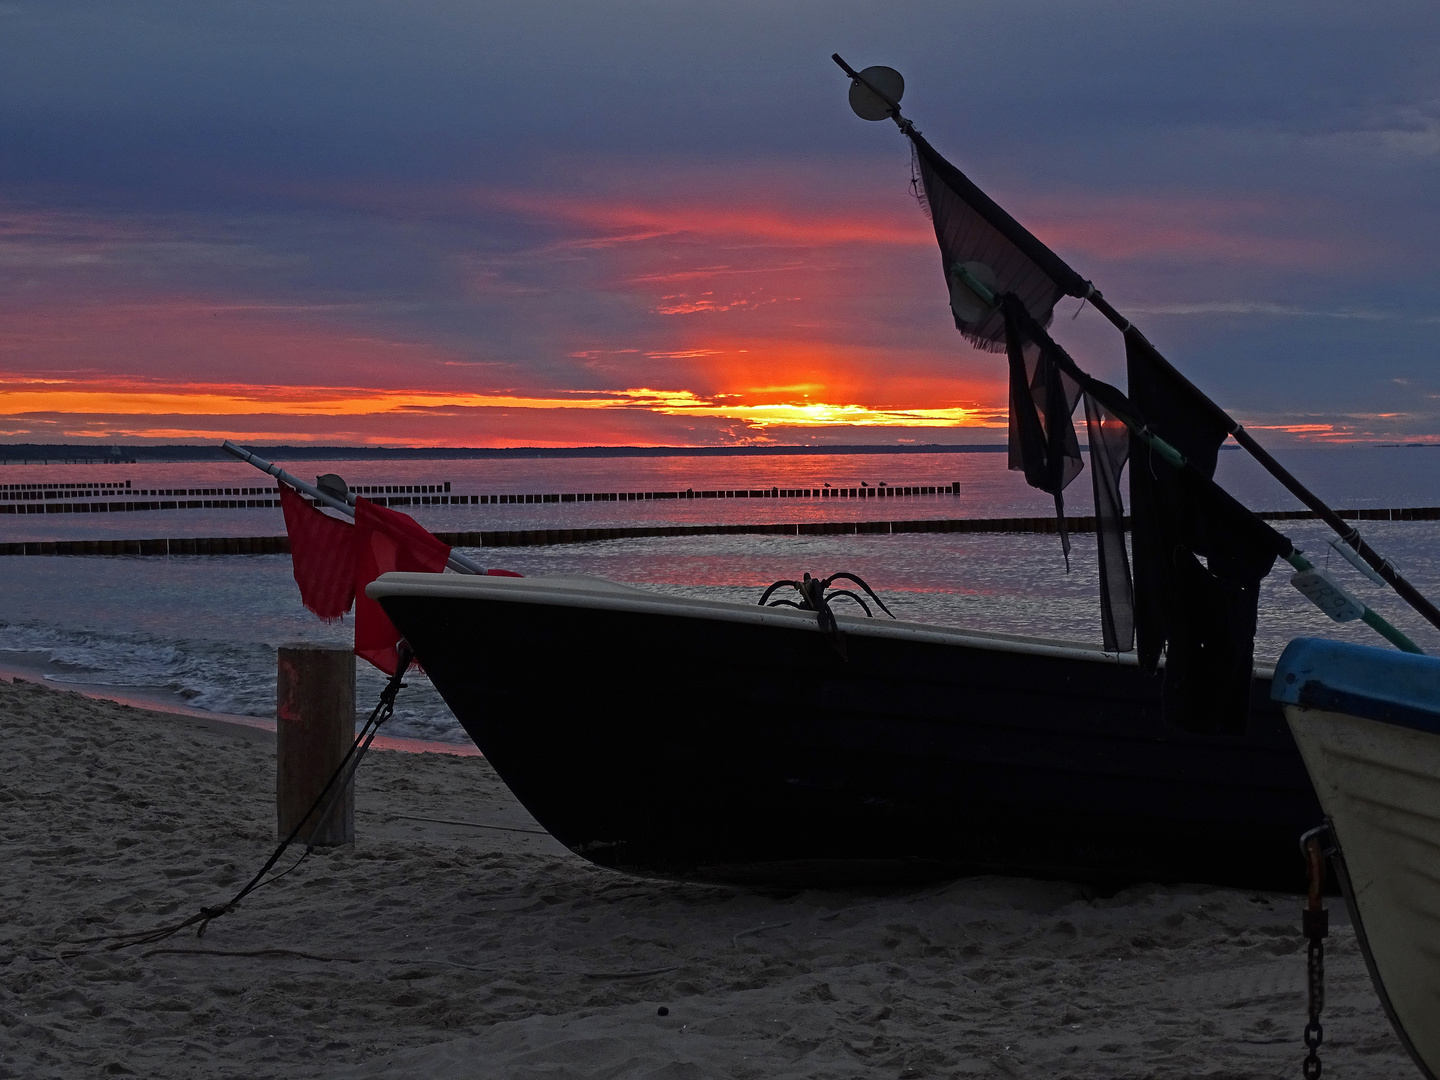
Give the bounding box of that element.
[0,0,1440,446]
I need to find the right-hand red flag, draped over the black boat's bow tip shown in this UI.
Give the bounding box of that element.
[354,498,449,675]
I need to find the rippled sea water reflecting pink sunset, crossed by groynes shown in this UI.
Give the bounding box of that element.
[0,448,1440,743]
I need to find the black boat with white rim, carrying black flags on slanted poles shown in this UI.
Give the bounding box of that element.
[256,56,1440,888]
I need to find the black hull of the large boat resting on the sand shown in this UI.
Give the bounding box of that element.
[376,587,1320,890]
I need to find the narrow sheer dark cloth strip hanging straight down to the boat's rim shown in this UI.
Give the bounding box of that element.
[1084,393,1135,652]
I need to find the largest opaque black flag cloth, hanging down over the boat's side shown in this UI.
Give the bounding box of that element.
[1125,333,1289,733]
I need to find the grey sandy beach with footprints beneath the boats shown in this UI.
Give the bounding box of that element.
[0,683,1414,1079]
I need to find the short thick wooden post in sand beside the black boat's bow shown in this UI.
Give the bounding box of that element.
[275,645,356,847]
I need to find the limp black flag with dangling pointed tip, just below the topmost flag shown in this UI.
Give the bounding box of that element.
[1001,295,1084,569]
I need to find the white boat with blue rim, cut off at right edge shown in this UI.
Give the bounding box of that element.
[1273,638,1440,1080]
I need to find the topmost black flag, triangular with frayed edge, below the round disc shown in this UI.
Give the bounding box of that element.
[906,131,1090,353]
